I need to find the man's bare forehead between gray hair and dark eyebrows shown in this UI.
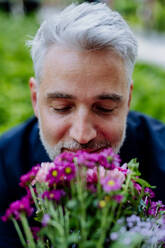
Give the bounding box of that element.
[41,46,127,97]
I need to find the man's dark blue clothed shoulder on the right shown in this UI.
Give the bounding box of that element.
[120,111,165,170]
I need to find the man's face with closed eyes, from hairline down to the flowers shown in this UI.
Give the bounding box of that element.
[30,46,131,159]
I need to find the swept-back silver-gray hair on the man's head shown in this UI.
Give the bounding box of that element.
[28,3,137,83]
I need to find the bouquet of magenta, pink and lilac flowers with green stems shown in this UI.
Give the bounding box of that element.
[2,148,165,248]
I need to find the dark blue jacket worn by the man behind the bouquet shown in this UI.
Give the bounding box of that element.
[0,112,165,248]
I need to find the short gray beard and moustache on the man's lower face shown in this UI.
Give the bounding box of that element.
[38,118,126,161]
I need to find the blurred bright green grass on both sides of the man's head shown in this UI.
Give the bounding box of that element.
[0,13,165,134]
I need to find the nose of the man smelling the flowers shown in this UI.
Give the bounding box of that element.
[70,107,97,144]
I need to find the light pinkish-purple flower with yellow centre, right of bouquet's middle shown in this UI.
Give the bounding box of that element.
[101,176,121,193]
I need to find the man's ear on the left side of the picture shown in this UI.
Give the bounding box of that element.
[29,77,38,117]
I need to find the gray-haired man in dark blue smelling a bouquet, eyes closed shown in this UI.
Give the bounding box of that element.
[0,3,165,248]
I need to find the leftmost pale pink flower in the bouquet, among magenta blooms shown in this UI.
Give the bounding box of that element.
[32,163,55,185]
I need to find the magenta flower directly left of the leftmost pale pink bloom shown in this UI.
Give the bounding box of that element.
[19,164,40,188]
